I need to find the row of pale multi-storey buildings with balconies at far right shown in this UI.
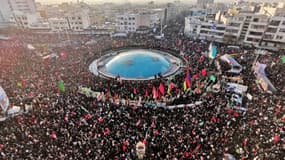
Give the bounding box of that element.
[184,8,285,50]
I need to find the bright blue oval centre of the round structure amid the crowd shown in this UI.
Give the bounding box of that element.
[105,50,171,78]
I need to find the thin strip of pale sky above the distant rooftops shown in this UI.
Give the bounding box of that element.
[35,0,283,4]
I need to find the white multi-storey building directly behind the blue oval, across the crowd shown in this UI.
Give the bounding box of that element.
[116,12,160,33]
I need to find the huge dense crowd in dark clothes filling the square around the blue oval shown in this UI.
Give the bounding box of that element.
[0,23,285,160]
